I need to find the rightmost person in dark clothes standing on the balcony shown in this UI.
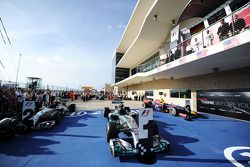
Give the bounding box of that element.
[230,15,246,34]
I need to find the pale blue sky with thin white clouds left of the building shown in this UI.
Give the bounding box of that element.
[0,0,137,90]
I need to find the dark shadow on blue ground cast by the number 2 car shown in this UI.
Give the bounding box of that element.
[0,109,100,156]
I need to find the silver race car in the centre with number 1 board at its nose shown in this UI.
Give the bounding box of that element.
[104,104,170,157]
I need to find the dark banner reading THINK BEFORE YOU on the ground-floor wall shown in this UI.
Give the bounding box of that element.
[197,89,250,121]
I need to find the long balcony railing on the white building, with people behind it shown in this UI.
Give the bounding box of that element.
[136,3,250,73]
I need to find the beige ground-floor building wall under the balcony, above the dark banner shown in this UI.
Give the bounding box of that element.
[126,67,250,111]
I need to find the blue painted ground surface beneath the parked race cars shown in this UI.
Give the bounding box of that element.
[0,111,250,167]
